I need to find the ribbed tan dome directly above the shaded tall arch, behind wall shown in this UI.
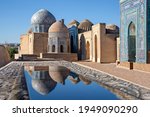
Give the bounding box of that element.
[78,19,93,31]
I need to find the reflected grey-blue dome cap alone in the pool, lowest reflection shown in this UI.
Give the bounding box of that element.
[32,78,57,95]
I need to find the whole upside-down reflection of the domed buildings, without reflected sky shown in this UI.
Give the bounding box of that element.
[25,66,91,95]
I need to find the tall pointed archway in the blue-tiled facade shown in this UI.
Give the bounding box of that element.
[128,22,136,62]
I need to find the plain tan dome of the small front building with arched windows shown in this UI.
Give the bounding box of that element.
[49,20,69,33]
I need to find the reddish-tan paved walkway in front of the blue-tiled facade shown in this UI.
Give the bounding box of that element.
[76,61,150,89]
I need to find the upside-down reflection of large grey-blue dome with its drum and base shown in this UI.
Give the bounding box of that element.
[26,66,57,95]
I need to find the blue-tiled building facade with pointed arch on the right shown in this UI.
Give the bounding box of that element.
[120,0,150,71]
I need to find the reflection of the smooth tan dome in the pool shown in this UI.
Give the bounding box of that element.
[49,66,70,84]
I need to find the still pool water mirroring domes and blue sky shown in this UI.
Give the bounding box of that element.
[25,66,118,100]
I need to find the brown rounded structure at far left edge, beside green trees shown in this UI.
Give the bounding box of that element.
[0,45,10,67]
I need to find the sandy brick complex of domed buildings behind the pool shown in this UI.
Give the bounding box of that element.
[16,9,119,63]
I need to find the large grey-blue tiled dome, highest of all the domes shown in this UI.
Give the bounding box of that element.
[31,9,56,25]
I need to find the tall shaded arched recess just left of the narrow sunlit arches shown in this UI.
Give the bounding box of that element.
[80,35,86,60]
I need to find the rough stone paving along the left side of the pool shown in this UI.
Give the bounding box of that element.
[0,62,28,100]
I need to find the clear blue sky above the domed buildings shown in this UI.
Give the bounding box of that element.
[0,0,120,43]
